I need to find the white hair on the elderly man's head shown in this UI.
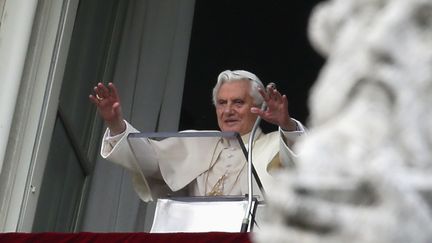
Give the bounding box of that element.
[213,70,265,106]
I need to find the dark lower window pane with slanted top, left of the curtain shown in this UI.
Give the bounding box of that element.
[33,118,86,232]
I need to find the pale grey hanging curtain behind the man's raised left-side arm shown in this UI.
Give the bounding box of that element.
[82,0,194,232]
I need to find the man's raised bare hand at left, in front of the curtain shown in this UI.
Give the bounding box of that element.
[89,83,126,136]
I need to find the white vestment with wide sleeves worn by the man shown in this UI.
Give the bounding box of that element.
[101,121,304,201]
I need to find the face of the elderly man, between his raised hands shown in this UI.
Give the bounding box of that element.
[216,80,257,135]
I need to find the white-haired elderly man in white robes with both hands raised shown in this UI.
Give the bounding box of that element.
[90,70,304,201]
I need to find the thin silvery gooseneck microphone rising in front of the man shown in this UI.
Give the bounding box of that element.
[240,83,276,232]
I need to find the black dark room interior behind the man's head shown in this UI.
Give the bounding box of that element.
[179,0,323,132]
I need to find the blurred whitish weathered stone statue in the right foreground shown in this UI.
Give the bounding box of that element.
[254,0,432,243]
